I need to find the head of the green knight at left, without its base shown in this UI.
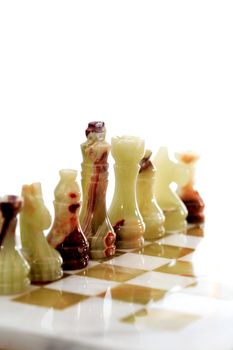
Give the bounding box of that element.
[22,182,51,231]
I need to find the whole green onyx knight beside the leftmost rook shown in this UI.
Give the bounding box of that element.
[20,183,63,282]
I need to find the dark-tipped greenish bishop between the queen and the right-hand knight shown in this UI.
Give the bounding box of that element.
[137,150,165,240]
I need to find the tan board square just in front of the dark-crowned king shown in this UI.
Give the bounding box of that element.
[77,263,145,282]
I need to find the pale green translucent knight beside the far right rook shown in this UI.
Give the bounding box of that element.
[154,147,188,232]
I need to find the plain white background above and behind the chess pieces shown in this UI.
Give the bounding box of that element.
[0,0,233,246]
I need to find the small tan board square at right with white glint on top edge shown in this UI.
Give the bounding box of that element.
[154,260,195,277]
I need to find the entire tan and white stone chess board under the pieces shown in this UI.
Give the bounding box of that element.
[0,228,233,350]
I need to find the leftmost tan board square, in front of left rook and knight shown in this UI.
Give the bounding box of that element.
[12,288,88,310]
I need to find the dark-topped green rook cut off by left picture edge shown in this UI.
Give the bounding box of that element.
[0,196,30,294]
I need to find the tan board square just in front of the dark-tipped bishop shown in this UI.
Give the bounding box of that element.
[133,243,194,259]
